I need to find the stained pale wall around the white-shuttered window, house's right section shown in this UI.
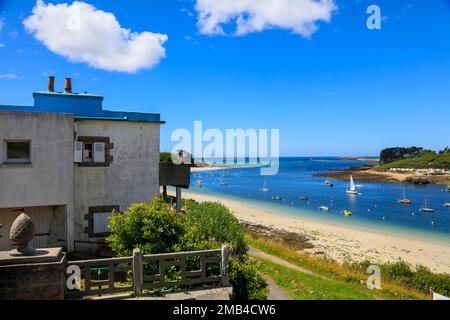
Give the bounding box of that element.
[74,120,160,248]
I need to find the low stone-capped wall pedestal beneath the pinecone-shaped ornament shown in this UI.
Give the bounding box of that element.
[0,248,66,300]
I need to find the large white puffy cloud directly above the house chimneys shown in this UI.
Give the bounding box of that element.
[23,0,168,73]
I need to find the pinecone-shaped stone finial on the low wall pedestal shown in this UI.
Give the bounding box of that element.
[9,213,36,256]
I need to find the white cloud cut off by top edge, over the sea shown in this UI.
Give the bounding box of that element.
[195,0,337,37]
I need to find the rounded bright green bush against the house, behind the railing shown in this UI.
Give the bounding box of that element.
[107,197,185,256]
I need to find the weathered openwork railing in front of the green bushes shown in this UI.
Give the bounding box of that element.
[66,246,229,298]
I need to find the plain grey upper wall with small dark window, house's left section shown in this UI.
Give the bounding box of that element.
[0,111,73,208]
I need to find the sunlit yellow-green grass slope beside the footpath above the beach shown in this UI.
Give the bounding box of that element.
[246,235,428,300]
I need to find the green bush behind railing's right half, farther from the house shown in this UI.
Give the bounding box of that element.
[184,202,248,256]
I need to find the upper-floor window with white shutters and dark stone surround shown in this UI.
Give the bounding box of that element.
[74,137,113,167]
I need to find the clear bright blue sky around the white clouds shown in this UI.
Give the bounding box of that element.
[0,0,450,156]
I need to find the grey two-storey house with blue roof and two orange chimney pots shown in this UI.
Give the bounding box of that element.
[0,77,163,251]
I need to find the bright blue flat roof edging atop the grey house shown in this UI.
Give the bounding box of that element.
[0,92,164,123]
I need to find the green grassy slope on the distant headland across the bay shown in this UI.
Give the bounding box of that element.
[376,151,450,171]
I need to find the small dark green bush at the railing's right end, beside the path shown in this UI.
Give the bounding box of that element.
[228,258,269,301]
